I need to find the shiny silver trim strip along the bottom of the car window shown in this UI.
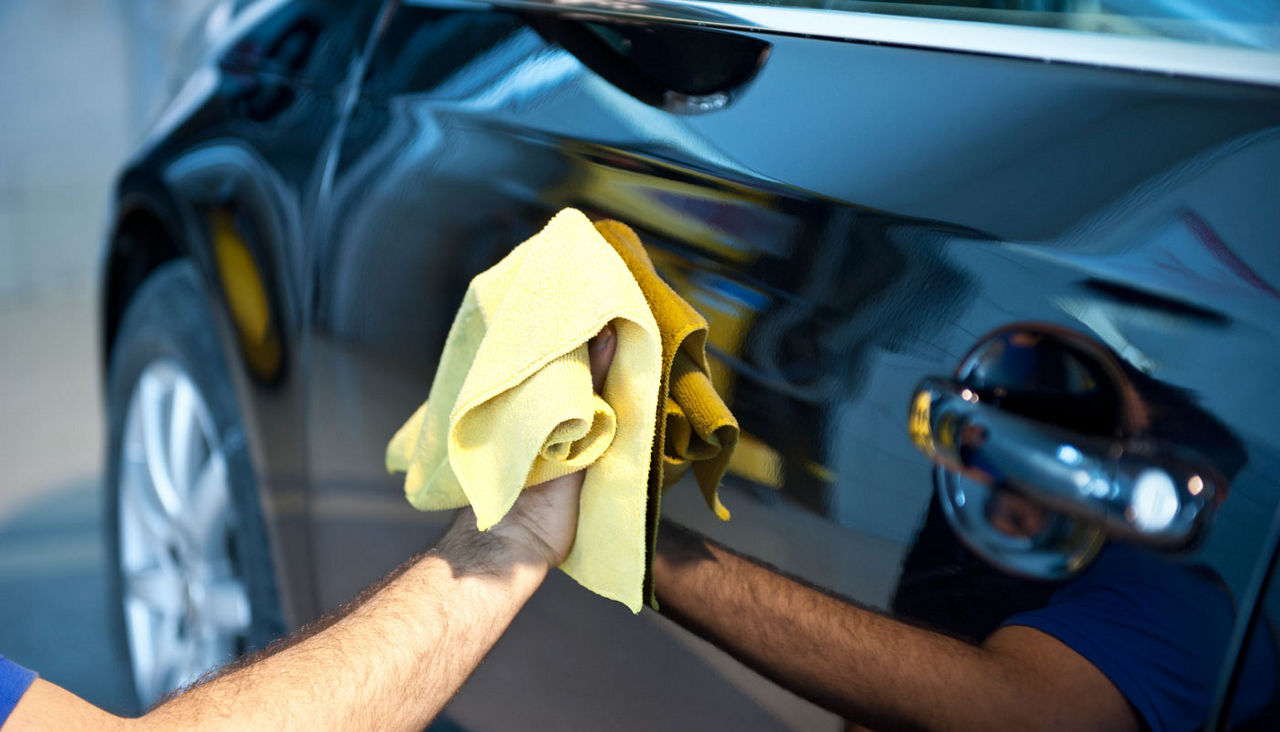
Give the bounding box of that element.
[408,0,1280,87]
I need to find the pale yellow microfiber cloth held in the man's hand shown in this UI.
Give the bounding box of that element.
[387,209,663,613]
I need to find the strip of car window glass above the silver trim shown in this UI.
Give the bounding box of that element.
[721,0,1280,49]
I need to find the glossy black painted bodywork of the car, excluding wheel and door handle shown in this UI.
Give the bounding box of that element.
[104,1,1280,729]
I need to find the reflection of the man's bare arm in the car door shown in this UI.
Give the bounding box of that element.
[654,522,1132,729]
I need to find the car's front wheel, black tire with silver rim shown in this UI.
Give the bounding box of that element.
[104,260,283,708]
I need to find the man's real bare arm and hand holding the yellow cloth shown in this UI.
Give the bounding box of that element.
[5,326,617,732]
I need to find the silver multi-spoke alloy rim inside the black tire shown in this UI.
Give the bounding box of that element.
[118,360,251,705]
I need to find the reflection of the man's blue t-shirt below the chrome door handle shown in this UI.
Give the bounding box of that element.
[1004,544,1276,731]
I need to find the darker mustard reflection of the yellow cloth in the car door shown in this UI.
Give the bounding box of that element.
[595,221,739,603]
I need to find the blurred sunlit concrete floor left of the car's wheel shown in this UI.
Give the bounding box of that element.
[0,290,134,713]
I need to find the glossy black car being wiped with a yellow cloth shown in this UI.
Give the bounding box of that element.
[101,0,1280,729]
